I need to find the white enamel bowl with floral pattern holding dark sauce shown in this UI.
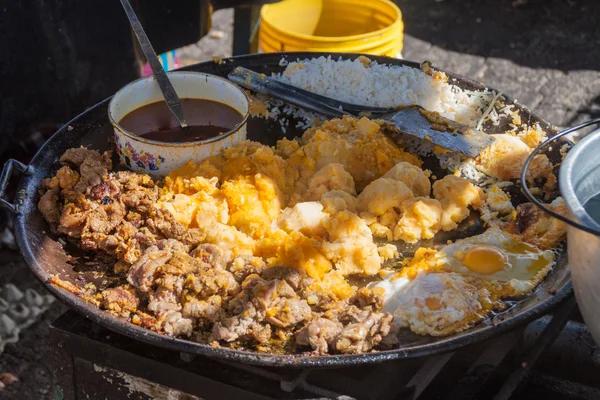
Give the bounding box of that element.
[108,71,250,176]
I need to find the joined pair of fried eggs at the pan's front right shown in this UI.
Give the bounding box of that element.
[370,227,554,336]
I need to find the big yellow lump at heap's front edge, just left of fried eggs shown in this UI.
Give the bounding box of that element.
[321,211,381,276]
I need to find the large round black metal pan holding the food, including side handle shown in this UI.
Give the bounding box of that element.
[0,53,572,367]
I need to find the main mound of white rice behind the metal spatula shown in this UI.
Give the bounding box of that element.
[274,57,494,127]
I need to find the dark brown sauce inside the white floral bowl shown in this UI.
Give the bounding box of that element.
[119,99,243,143]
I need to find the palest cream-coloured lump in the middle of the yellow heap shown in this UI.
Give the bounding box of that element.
[277,201,328,237]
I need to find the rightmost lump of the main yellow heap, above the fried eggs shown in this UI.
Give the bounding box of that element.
[433,176,486,231]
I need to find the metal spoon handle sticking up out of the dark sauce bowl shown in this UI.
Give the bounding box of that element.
[121,0,187,128]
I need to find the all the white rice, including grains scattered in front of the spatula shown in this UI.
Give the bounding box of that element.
[254,57,524,182]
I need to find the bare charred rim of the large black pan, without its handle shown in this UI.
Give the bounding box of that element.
[15,52,573,368]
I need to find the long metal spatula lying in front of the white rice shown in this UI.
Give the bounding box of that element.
[228,67,495,157]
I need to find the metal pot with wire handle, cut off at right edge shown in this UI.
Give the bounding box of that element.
[521,119,600,343]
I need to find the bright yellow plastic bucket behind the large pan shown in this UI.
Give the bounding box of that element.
[258,0,404,57]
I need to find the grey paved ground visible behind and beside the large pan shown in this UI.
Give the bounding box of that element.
[0,0,600,400]
